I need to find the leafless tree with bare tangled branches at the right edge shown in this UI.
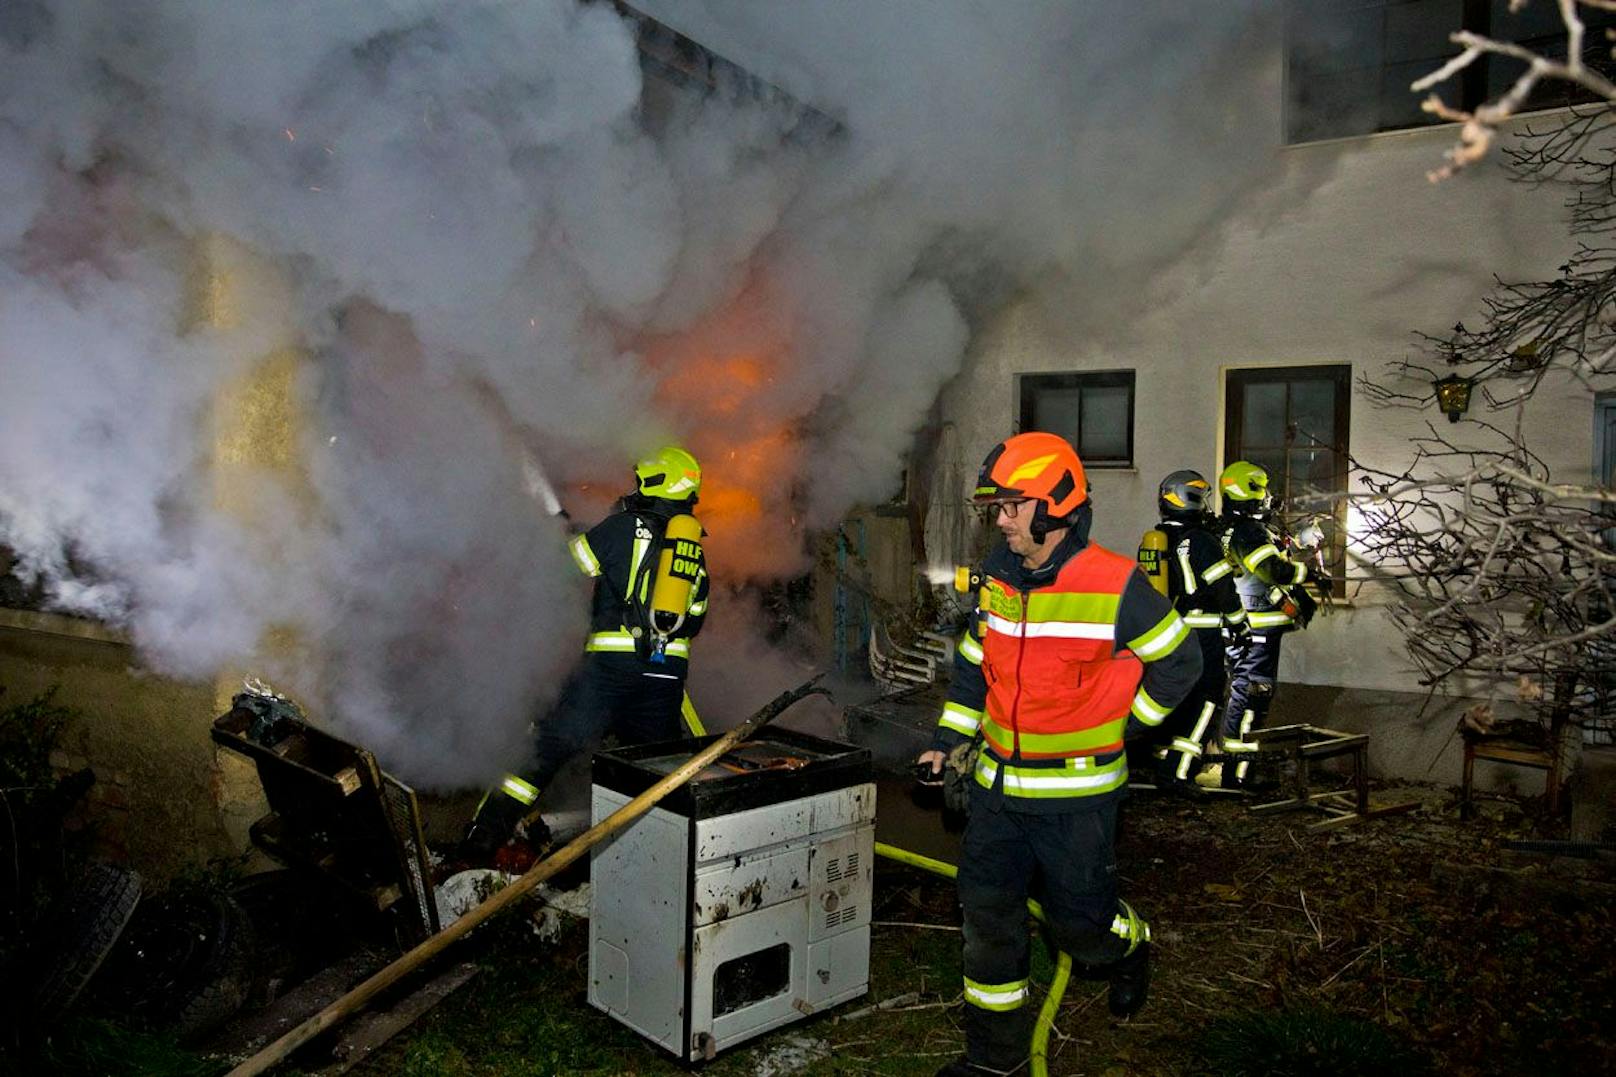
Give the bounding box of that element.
[1351,0,1616,747]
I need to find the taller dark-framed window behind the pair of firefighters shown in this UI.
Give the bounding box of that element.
[1223,364,1353,581]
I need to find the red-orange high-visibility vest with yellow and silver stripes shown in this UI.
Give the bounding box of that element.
[978,545,1144,760]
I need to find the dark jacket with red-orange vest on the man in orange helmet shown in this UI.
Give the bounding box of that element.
[934,534,1201,810]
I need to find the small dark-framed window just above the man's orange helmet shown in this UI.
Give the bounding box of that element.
[1016,370,1133,467]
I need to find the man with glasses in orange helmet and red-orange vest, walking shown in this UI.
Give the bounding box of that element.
[918,433,1201,1074]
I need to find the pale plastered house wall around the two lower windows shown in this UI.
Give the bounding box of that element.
[942,113,1593,789]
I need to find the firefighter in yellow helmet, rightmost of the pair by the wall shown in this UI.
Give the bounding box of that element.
[1209,459,1330,789]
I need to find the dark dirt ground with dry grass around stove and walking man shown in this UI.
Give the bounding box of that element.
[344,786,1616,1077]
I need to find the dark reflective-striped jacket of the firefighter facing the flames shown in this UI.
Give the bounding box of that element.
[567,496,709,676]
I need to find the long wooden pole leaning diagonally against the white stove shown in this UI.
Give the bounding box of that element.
[226,676,829,1077]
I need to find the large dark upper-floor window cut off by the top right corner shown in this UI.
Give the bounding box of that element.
[1285,0,1616,142]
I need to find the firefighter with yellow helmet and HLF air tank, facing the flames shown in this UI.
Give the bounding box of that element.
[461,446,708,862]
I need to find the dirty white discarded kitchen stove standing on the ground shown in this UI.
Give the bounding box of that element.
[588,729,876,1061]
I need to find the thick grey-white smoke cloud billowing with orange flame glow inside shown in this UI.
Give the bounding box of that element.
[0,0,1278,784]
